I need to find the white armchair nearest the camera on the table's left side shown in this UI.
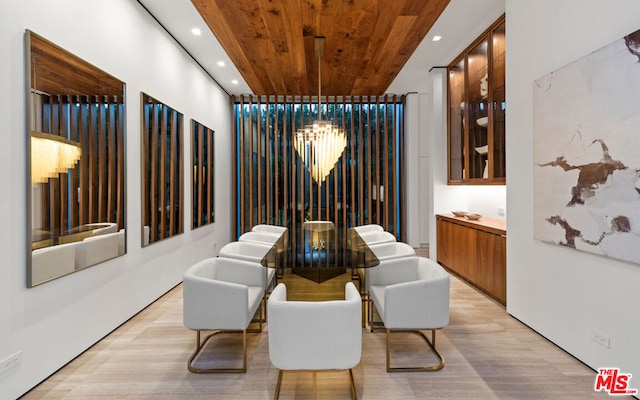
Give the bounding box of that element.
[183,257,265,373]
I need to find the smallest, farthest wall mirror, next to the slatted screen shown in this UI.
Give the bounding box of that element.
[191,120,215,229]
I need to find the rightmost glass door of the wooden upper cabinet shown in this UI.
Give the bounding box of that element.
[491,21,507,178]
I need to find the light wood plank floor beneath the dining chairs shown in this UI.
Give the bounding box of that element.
[23,252,609,400]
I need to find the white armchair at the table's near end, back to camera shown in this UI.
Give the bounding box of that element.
[267,282,362,399]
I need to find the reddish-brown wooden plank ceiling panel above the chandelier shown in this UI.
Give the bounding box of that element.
[192,0,449,96]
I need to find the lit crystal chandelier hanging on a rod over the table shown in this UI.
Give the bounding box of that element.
[294,36,347,182]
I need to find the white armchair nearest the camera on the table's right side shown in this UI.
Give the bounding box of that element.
[367,257,449,372]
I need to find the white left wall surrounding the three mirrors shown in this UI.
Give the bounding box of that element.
[0,0,231,399]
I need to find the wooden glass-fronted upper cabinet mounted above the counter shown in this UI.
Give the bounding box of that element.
[447,15,506,185]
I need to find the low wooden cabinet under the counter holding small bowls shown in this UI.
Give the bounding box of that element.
[436,215,507,305]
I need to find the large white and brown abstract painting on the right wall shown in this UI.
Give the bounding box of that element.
[533,30,640,263]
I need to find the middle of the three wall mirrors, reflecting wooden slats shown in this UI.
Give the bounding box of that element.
[141,93,184,246]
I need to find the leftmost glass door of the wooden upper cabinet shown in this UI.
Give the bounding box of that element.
[449,58,465,180]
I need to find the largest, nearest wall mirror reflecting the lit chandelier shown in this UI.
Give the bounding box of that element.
[25,30,126,287]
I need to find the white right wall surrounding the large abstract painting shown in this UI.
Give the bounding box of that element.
[506,0,640,388]
